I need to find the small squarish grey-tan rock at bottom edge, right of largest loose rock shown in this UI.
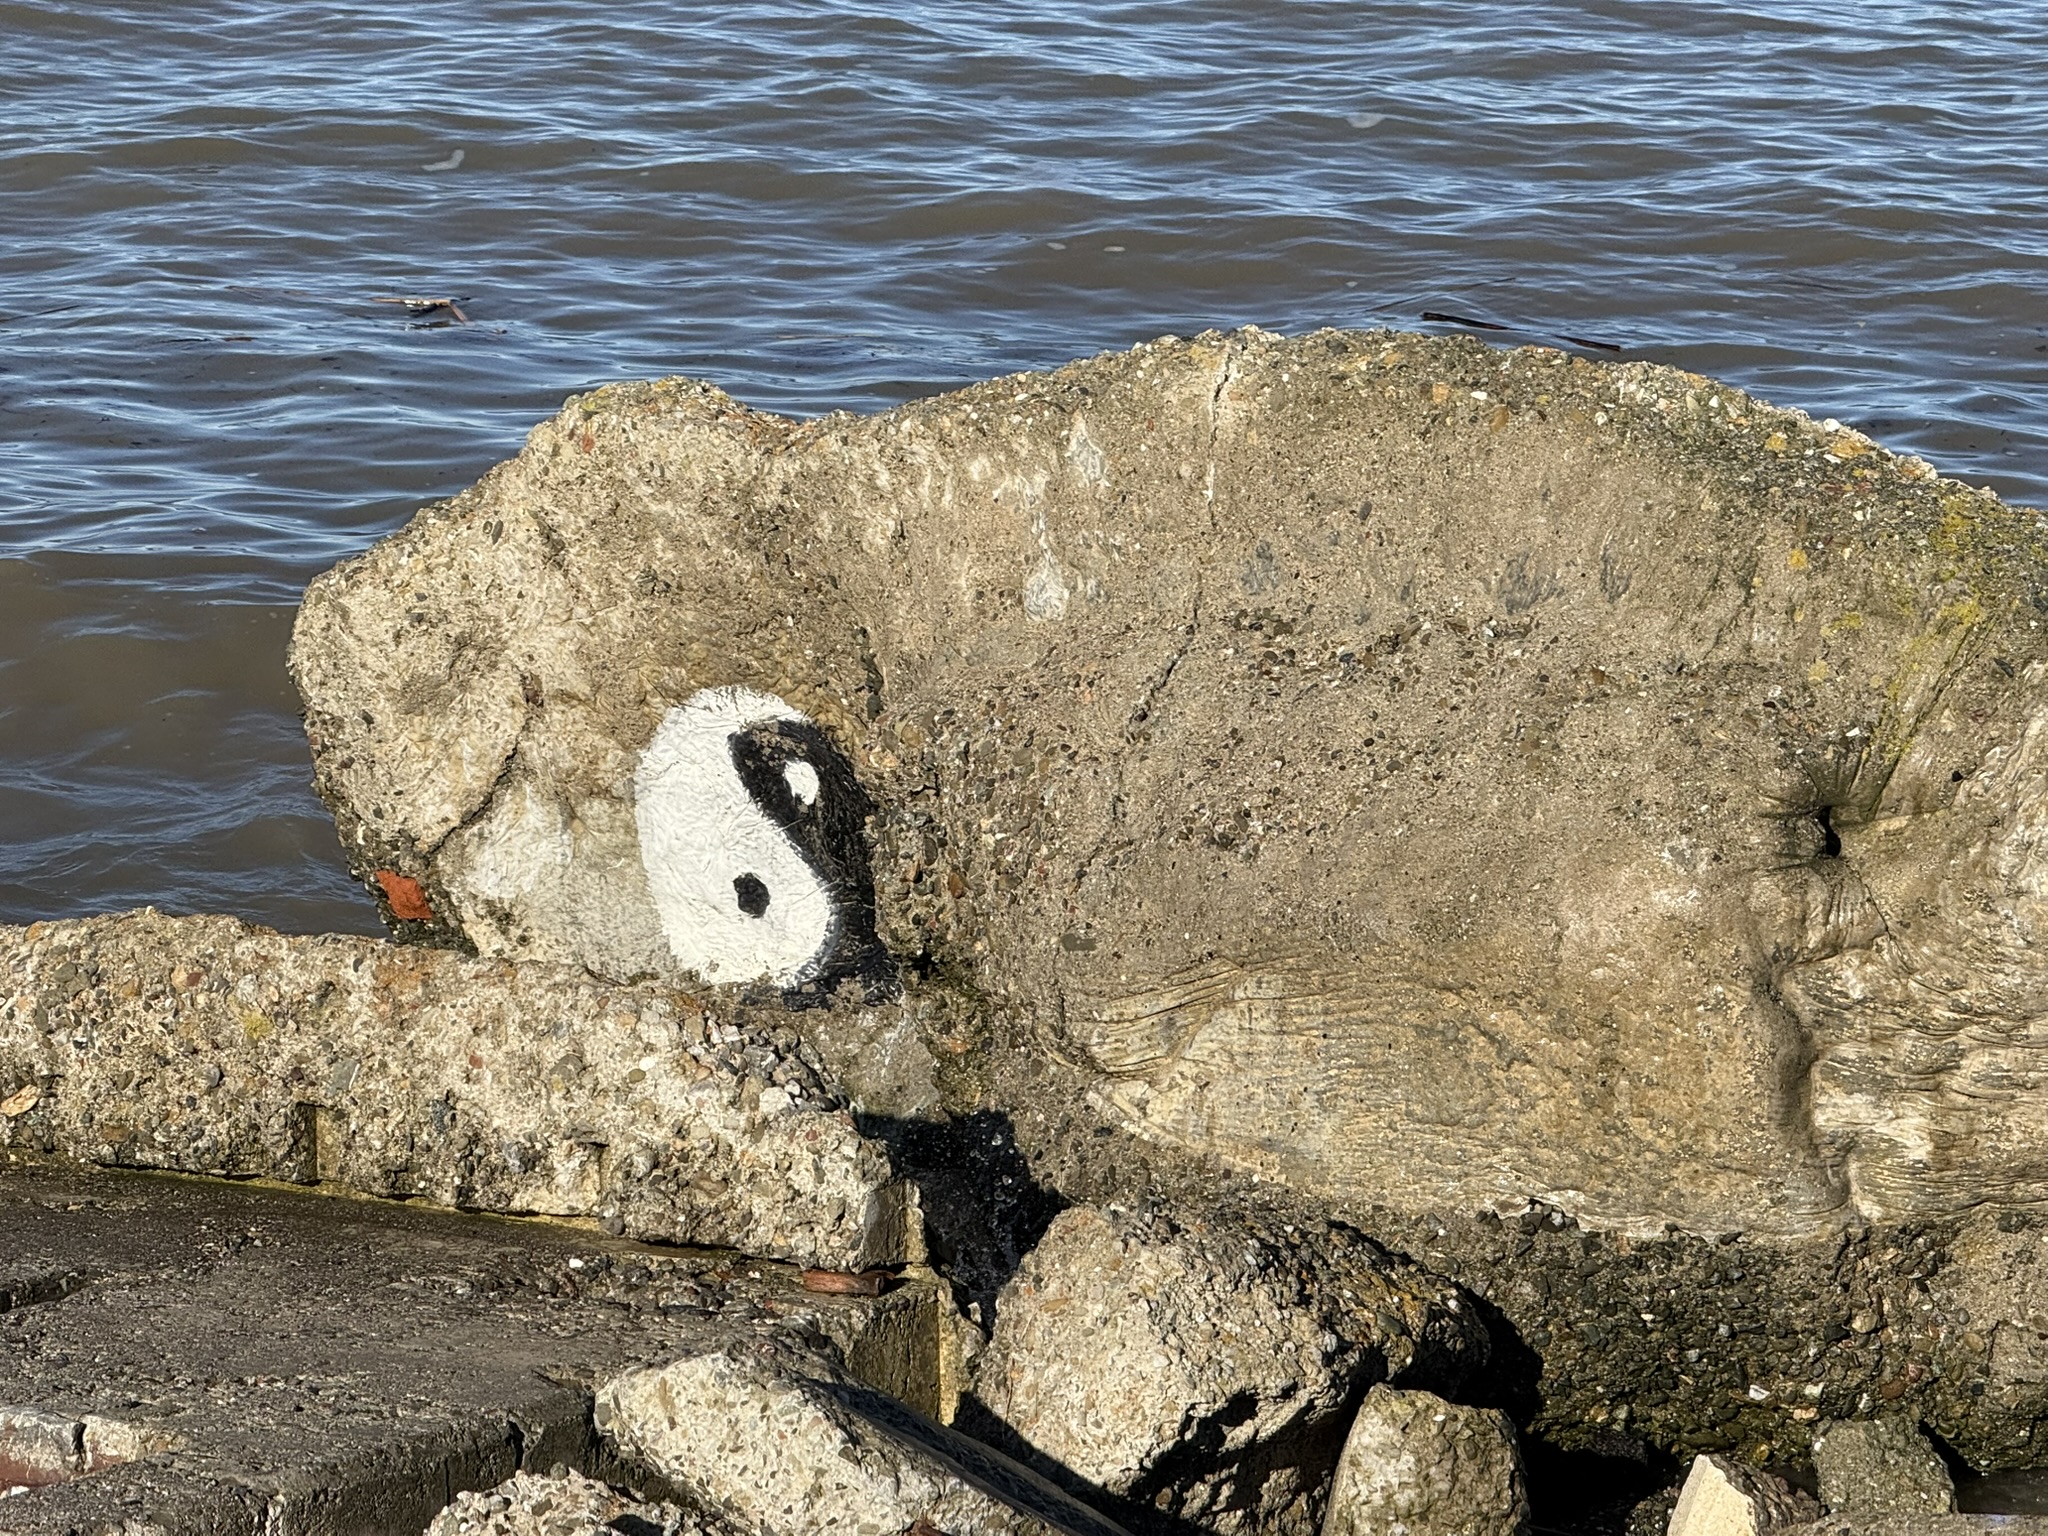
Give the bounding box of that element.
[1323,1386,1530,1536]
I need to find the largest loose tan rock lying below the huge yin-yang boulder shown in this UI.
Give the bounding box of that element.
[963,1206,1485,1532]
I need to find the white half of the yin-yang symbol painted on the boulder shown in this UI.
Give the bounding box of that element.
[633,688,834,987]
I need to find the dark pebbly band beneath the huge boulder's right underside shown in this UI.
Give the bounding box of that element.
[1253,1208,2048,1468]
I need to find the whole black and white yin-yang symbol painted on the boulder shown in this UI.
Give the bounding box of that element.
[633,688,895,1001]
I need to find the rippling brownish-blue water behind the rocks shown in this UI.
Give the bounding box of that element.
[0,0,2048,930]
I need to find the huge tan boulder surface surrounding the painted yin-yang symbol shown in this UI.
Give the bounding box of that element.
[293,332,2048,1235]
